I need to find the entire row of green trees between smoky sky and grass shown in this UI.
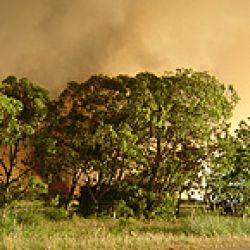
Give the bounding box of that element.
[0,69,250,217]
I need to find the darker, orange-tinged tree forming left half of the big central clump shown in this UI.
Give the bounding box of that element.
[36,75,139,210]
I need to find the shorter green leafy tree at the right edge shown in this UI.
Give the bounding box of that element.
[208,118,250,214]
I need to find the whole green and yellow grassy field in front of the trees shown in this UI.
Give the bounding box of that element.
[0,201,250,249]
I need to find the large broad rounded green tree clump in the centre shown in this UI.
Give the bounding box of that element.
[34,69,238,216]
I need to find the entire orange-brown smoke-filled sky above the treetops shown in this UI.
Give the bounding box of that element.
[0,0,250,128]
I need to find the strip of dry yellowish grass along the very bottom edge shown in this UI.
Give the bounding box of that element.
[1,230,250,250]
